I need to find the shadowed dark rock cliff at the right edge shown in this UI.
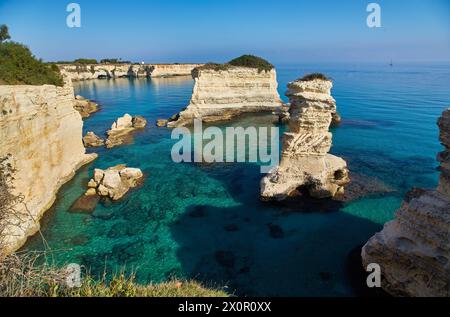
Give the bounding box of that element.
[362,109,450,297]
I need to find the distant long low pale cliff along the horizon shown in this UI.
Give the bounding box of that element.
[59,64,201,81]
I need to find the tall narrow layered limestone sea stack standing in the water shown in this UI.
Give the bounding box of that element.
[261,79,349,200]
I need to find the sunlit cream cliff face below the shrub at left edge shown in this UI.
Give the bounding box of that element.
[0,82,95,252]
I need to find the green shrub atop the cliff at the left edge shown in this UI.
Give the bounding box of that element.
[0,42,64,86]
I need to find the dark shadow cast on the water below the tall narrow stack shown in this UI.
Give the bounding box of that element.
[171,165,381,296]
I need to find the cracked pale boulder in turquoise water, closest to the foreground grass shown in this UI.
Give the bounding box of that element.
[85,165,144,200]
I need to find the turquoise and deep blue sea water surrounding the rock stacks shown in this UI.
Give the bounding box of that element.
[26,64,450,296]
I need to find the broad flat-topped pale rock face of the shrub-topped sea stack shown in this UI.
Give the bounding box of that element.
[168,66,283,127]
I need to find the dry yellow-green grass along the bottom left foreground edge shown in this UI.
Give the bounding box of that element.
[0,253,230,297]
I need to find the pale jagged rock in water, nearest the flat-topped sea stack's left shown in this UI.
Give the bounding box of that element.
[106,114,147,149]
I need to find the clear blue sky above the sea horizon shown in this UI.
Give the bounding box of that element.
[0,0,450,63]
